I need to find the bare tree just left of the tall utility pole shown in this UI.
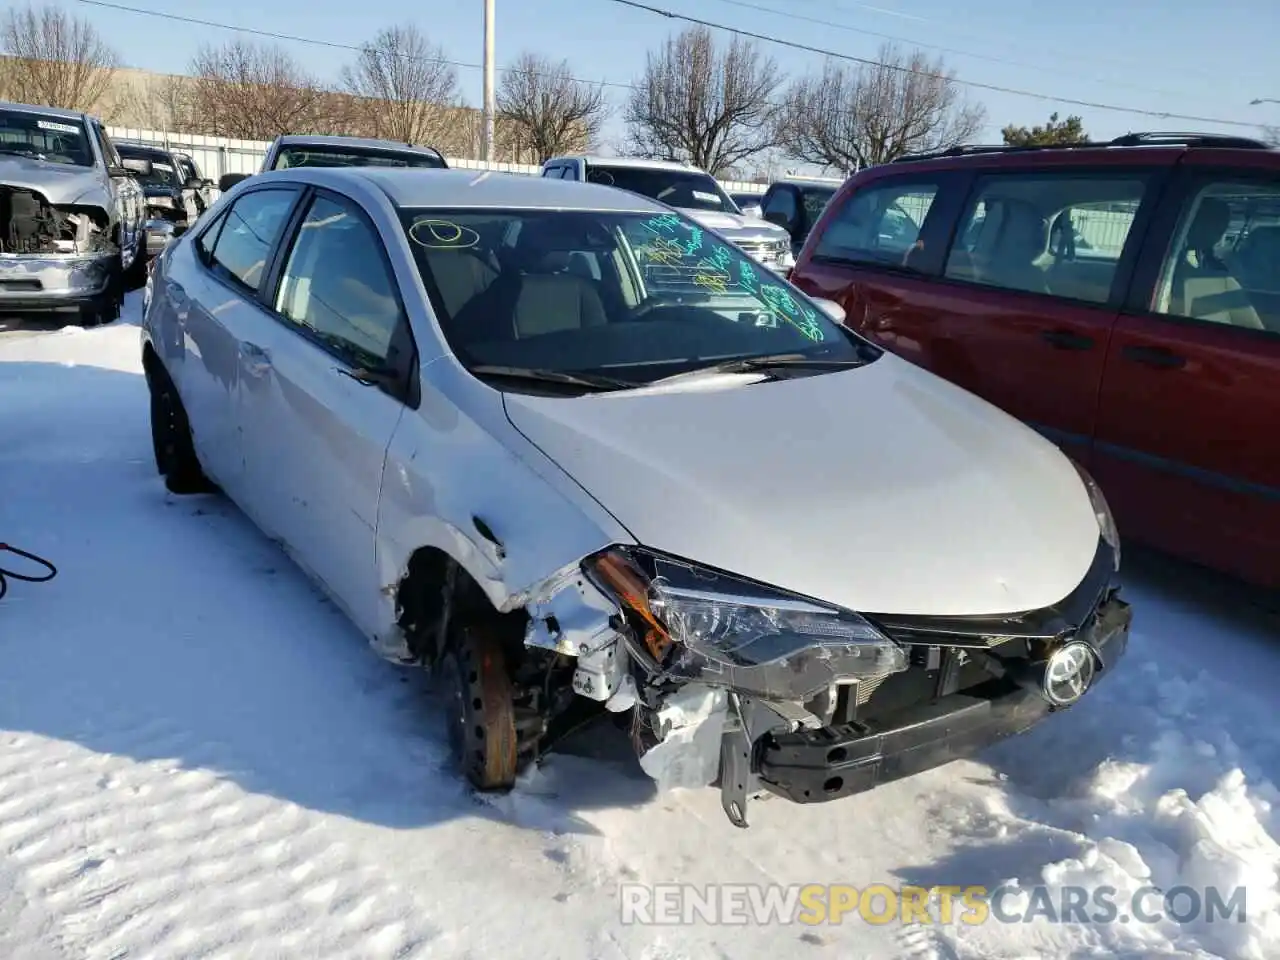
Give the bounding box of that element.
[342,24,458,145]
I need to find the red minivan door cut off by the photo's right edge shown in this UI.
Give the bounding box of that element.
[1094,151,1280,586]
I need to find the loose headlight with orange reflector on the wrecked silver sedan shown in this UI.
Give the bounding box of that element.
[584,548,908,703]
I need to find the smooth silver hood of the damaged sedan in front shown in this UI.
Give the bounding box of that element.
[504,355,1098,616]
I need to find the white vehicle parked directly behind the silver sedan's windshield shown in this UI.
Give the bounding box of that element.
[543,156,795,273]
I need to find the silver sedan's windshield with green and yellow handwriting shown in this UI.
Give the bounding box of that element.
[402,209,874,385]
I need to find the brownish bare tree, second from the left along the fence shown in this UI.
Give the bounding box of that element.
[191,40,338,140]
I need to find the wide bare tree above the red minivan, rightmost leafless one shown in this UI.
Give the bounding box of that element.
[780,44,987,173]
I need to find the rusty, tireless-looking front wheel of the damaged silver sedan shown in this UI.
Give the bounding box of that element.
[440,623,518,791]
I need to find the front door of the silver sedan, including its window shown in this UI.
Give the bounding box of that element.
[242,192,413,632]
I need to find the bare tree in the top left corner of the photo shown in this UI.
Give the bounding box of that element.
[0,5,119,111]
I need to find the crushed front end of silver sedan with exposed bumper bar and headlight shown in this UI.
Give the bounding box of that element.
[550,538,1130,827]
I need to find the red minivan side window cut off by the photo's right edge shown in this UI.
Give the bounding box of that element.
[1155,182,1280,333]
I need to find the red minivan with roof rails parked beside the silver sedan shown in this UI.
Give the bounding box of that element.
[791,133,1280,588]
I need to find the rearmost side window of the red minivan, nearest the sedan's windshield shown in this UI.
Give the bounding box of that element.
[813,183,938,266]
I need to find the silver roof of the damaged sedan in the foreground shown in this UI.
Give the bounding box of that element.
[252,166,671,214]
